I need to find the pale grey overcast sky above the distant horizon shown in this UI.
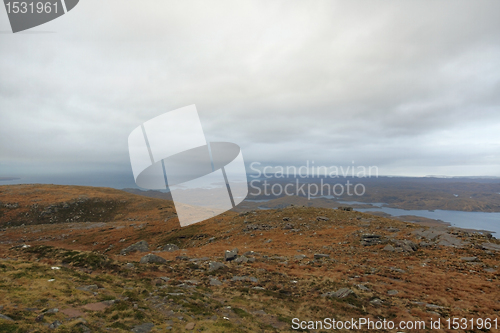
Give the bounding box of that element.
[0,0,500,182]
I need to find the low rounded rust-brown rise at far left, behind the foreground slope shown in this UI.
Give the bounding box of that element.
[0,185,175,227]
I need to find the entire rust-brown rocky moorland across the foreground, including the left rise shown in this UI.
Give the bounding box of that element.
[0,186,500,332]
